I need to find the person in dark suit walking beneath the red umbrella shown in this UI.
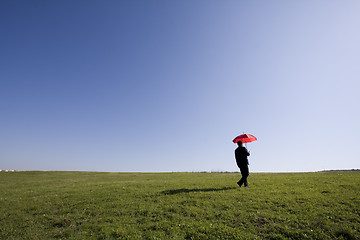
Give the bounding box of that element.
[235,141,250,187]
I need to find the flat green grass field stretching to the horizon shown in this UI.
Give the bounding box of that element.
[0,172,360,239]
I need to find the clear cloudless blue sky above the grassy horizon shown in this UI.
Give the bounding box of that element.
[0,0,360,172]
